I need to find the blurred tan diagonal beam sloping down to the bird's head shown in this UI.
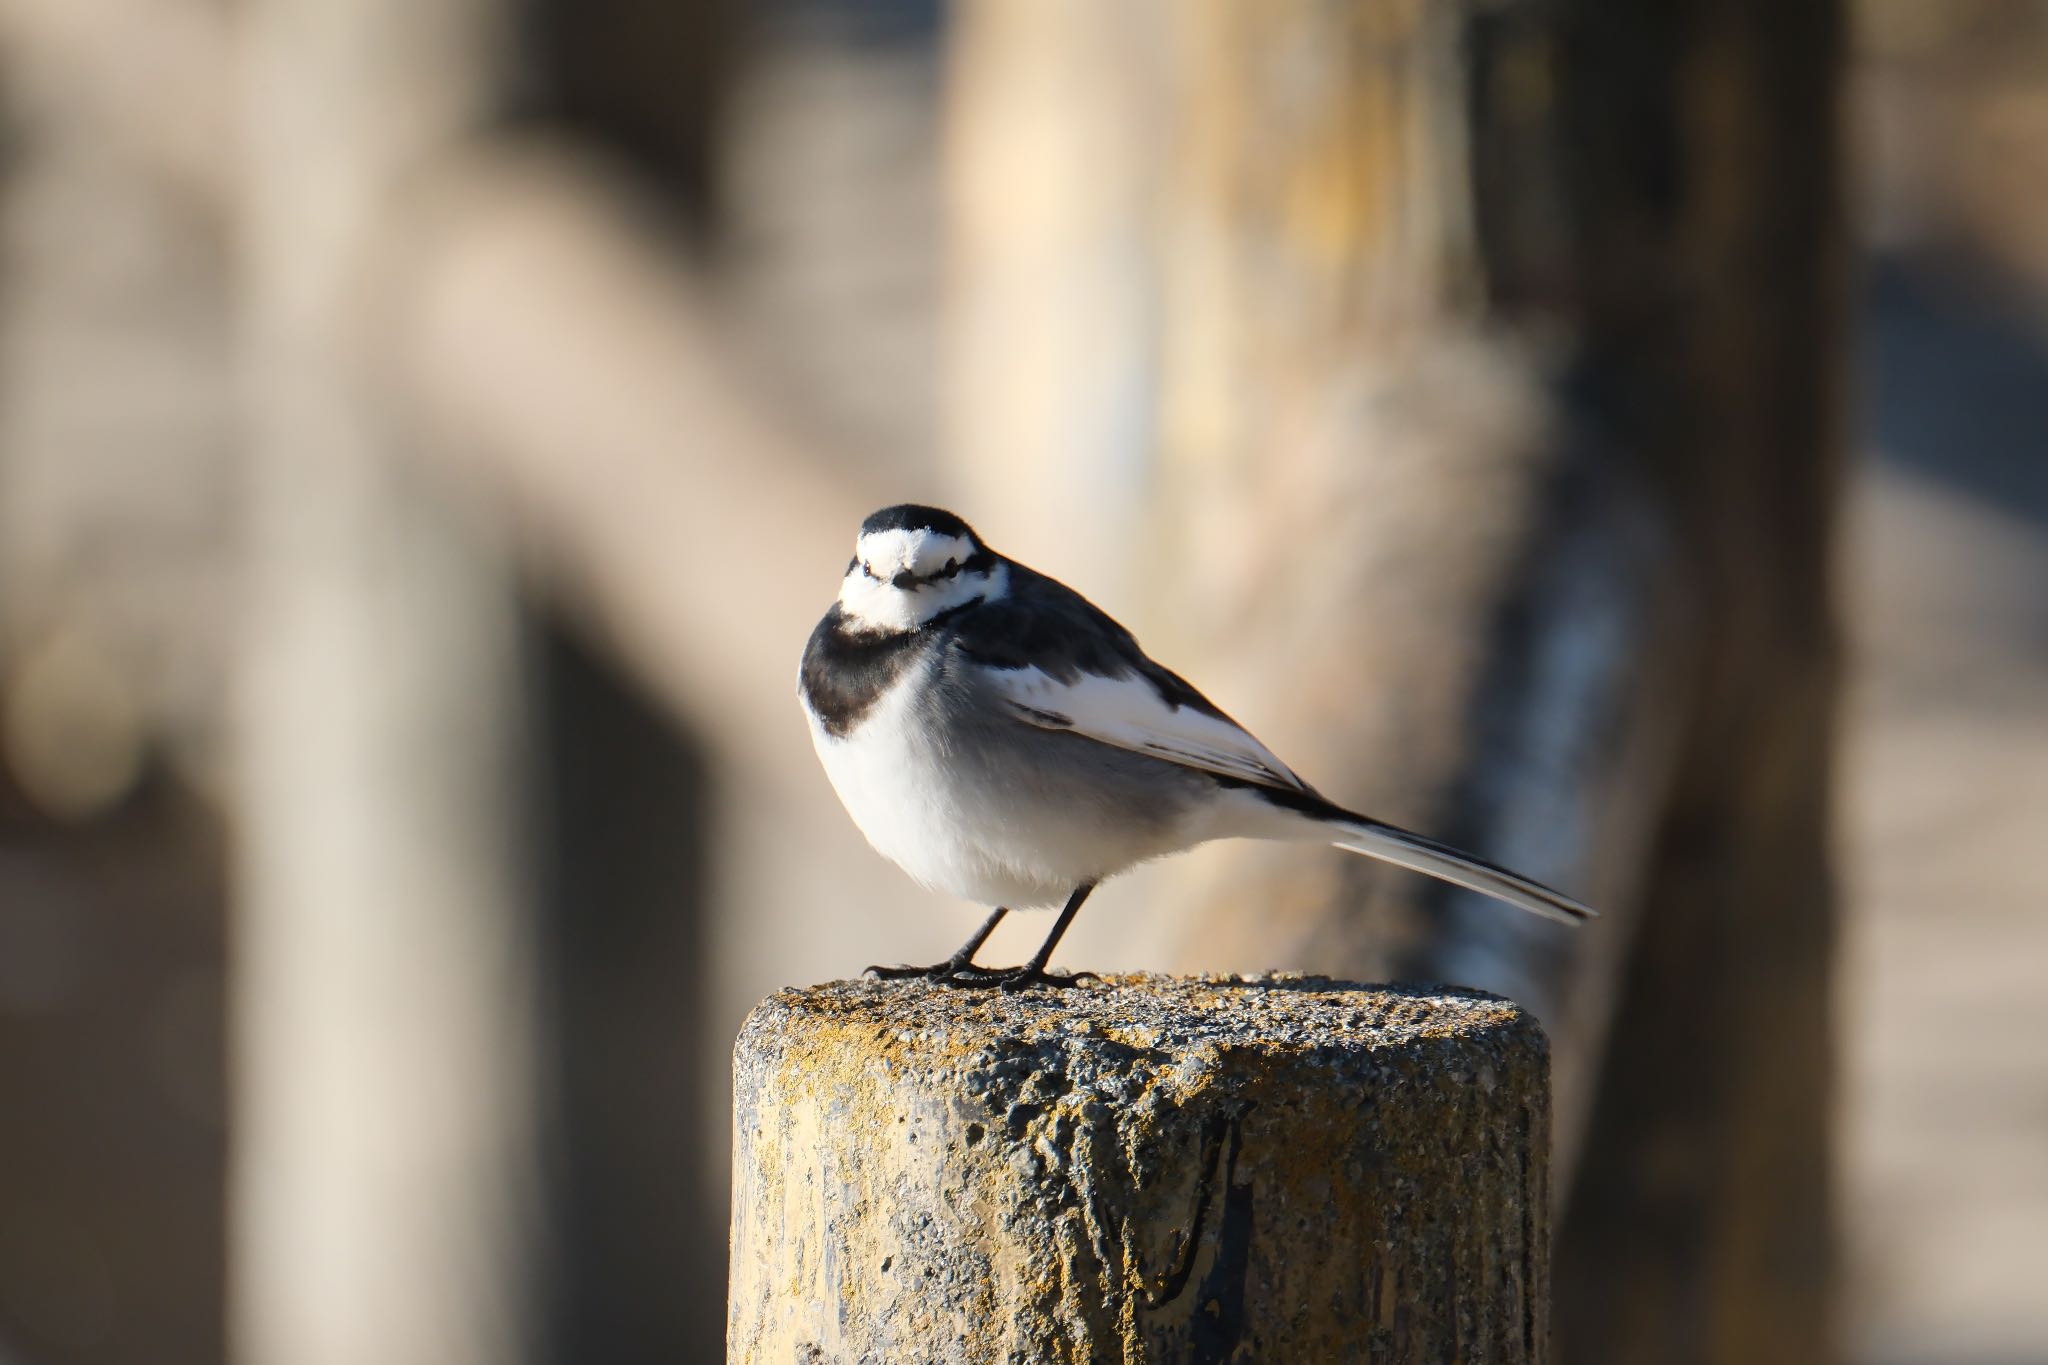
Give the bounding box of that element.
[391,147,881,774]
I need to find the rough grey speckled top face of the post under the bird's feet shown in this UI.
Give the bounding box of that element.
[745,972,1544,1052]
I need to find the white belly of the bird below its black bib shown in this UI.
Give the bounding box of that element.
[811,671,1143,909]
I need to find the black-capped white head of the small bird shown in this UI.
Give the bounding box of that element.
[840,503,1010,632]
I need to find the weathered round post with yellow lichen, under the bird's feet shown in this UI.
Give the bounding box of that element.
[727,976,1550,1365]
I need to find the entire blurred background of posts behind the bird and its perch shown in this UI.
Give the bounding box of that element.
[0,0,2048,1365]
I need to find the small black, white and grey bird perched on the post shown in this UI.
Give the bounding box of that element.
[799,505,1593,988]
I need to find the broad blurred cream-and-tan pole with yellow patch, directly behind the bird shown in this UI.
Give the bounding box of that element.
[948,0,1679,1160]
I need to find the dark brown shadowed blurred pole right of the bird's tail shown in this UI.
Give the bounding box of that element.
[1554,0,1849,1365]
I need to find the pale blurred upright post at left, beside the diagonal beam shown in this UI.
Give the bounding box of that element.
[229,0,537,1365]
